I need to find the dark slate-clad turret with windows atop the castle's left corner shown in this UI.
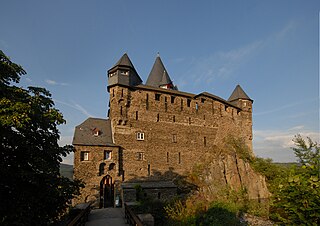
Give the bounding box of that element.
[108,53,142,90]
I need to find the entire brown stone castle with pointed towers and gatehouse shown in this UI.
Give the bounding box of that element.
[73,54,253,207]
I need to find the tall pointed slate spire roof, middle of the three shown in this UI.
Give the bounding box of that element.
[146,55,172,88]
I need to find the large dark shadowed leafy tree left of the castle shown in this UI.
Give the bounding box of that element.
[0,50,81,225]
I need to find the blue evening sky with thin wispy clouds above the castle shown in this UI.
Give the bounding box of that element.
[0,0,320,163]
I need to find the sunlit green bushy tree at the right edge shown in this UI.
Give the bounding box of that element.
[274,135,320,225]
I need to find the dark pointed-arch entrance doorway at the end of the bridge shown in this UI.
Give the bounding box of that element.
[100,175,114,208]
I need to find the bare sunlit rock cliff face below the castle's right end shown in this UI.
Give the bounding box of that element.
[195,154,270,201]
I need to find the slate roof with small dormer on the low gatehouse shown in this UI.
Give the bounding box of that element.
[72,118,116,146]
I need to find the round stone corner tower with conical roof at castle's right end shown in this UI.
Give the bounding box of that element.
[228,85,253,151]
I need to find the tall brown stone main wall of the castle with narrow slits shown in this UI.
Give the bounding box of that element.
[109,86,252,181]
